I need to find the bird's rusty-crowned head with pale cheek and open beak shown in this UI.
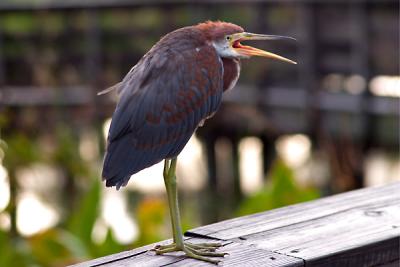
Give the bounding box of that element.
[197,21,297,64]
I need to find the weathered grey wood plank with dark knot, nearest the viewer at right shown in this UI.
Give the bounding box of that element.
[242,203,400,266]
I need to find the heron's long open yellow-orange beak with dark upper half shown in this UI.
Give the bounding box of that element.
[230,32,297,64]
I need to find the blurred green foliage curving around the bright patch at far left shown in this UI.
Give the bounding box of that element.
[0,125,131,267]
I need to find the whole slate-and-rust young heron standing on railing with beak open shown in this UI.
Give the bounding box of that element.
[100,21,296,263]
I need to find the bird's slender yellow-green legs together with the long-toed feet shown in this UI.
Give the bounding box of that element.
[154,158,227,263]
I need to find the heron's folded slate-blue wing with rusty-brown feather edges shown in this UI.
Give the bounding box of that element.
[102,46,223,188]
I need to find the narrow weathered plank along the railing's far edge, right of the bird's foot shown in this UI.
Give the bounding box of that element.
[189,182,400,239]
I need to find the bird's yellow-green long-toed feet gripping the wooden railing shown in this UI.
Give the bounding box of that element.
[153,242,228,264]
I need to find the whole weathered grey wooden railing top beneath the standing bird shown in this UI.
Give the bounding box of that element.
[74,182,400,267]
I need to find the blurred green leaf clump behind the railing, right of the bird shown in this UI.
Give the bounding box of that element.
[237,160,320,216]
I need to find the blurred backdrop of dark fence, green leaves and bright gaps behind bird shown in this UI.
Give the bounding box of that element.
[0,0,400,266]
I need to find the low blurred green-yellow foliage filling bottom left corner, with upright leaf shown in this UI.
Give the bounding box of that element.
[0,180,127,267]
